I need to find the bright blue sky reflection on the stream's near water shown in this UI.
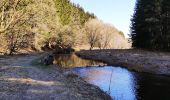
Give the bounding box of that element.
[74,66,137,100]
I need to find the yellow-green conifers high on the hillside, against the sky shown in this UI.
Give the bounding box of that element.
[54,0,95,25]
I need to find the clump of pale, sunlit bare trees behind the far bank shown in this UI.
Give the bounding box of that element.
[85,19,127,50]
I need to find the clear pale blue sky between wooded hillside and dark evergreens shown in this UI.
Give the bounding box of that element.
[71,0,136,37]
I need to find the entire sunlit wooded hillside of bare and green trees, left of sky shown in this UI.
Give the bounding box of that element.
[0,0,129,54]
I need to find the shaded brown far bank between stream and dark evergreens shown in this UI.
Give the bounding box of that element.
[76,49,170,76]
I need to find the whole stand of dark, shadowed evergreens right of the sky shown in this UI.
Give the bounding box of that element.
[131,0,170,51]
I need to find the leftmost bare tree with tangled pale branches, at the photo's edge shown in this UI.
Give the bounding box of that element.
[0,0,34,54]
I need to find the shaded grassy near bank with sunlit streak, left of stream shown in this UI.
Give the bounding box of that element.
[0,54,111,100]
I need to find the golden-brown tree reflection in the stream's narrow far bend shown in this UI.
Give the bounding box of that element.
[54,54,103,68]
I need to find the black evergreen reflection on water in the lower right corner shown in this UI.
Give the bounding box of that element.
[136,73,170,100]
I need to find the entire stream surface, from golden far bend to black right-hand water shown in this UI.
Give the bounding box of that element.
[56,55,170,100]
